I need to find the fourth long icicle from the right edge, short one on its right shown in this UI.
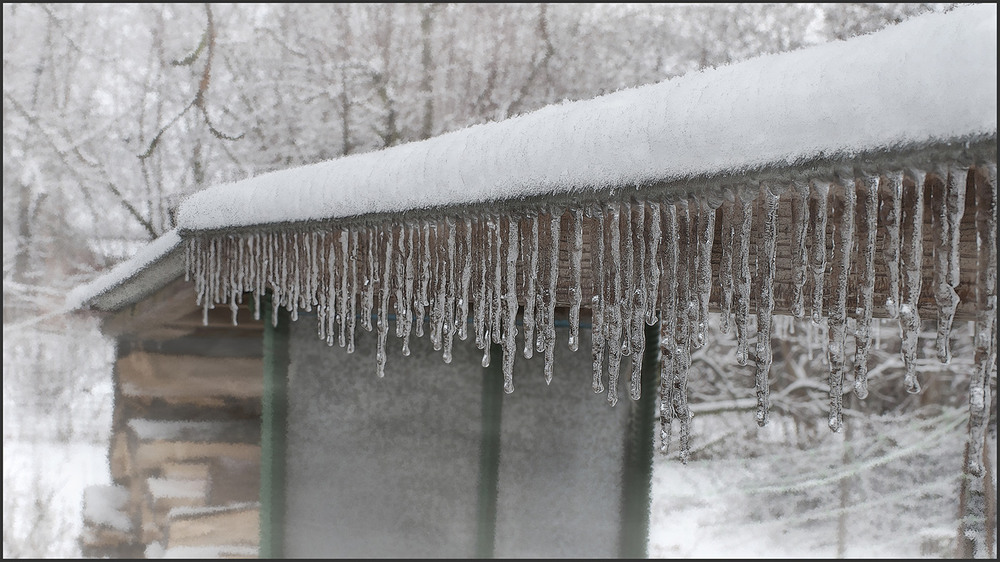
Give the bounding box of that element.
[854,176,879,400]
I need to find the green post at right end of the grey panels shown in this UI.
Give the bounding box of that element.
[618,325,660,558]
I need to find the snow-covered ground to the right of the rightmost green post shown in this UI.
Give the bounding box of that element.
[648,409,980,558]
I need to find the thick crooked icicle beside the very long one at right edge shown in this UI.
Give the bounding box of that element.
[934,166,965,363]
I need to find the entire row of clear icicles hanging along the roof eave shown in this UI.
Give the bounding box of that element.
[186,164,996,460]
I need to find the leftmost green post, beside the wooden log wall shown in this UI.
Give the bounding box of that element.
[260,294,291,558]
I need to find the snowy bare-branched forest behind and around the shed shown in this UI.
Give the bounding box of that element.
[3,3,995,557]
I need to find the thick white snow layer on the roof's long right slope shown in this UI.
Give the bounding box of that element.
[179,5,997,231]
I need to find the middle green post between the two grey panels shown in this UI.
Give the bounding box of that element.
[476,344,503,558]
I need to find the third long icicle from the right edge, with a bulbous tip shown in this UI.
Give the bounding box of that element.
[899,170,927,394]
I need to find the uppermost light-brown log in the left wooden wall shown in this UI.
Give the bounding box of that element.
[116,352,263,398]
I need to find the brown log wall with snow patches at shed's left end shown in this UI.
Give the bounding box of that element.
[81,279,263,557]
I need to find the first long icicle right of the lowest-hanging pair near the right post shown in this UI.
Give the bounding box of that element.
[754,185,778,427]
